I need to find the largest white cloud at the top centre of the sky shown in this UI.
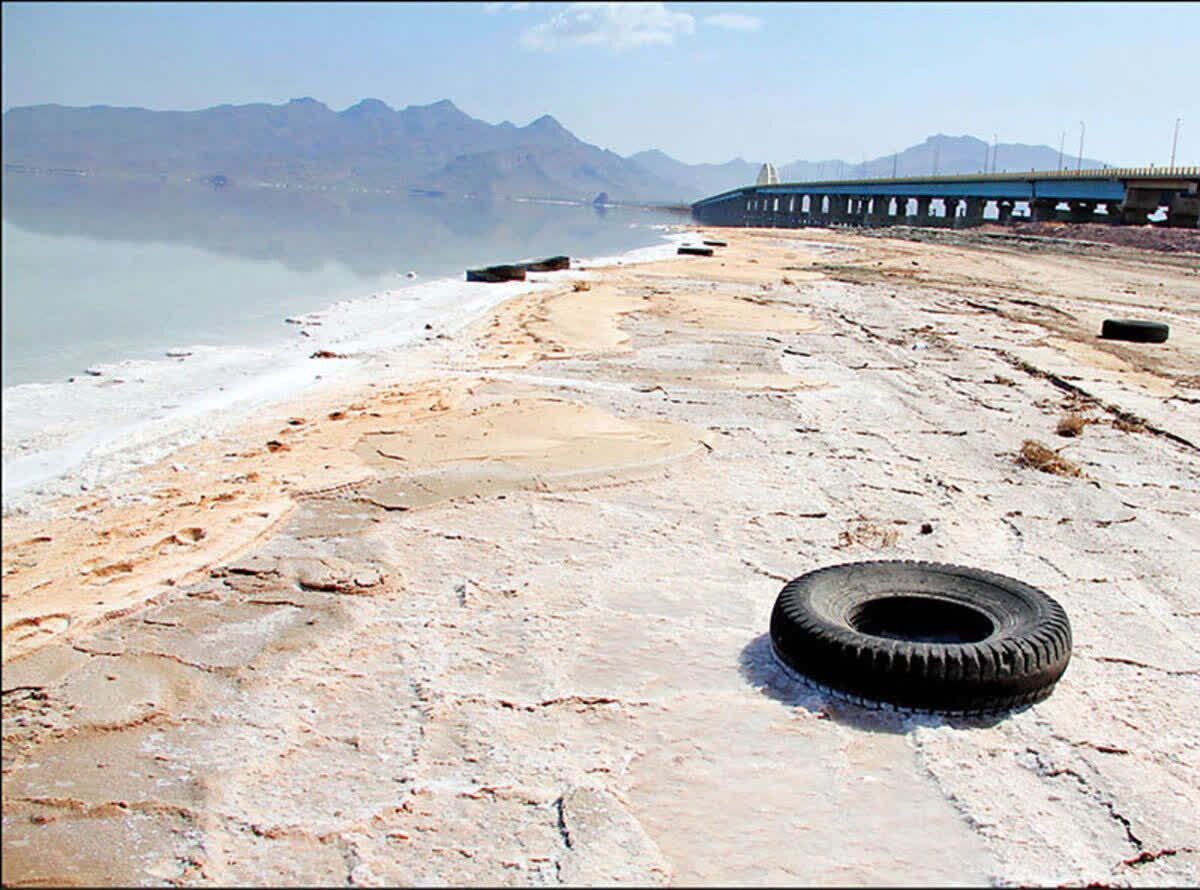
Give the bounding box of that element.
[521,2,696,50]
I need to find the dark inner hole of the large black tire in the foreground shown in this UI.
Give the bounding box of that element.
[848,596,995,643]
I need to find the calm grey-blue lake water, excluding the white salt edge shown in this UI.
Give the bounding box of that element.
[2,174,685,387]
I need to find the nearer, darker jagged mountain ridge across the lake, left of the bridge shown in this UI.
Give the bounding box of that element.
[4,98,685,200]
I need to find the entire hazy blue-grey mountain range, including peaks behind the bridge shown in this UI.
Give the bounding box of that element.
[2,98,1102,203]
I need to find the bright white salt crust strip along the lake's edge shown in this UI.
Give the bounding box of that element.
[2,225,691,516]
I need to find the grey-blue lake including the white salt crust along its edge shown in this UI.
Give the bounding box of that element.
[2,174,686,510]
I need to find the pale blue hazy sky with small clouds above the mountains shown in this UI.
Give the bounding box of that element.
[2,2,1200,164]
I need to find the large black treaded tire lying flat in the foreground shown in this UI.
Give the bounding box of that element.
[770,561,1070,714]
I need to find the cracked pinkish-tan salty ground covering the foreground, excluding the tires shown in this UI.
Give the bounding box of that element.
[2,230,1200,886]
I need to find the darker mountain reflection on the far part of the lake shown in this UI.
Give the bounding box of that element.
[4,174,683,277]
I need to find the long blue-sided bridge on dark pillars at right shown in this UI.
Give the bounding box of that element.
[691,167,1200,228]
